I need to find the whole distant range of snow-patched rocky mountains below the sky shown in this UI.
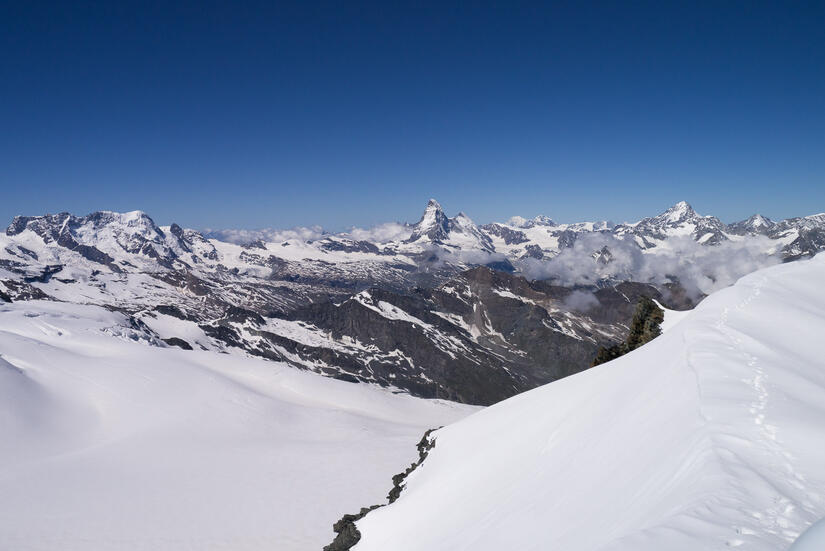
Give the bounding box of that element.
[0,200,825,404]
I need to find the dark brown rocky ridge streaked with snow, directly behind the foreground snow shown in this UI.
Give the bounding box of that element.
[188,267,663,405]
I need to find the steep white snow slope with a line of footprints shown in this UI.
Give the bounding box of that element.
[354,255,825,551]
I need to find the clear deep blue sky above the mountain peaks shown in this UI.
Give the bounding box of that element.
[0,1,825,229]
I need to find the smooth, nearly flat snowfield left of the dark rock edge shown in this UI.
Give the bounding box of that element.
[0,301,477,551]
